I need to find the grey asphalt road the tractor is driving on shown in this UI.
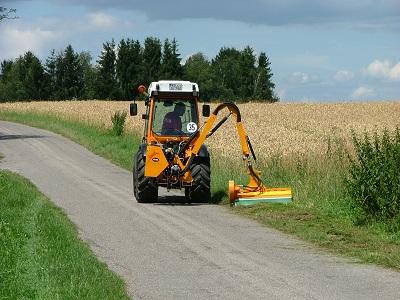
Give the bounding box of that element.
[0,121,400,299]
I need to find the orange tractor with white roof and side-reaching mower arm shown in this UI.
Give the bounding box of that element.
[130,81,292,205]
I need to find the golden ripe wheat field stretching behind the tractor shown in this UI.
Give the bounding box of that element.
[0,100,400,157]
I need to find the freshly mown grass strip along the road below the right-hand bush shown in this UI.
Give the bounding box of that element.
[236,204,400,270]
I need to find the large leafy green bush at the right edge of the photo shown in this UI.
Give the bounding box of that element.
[346,128,400,220]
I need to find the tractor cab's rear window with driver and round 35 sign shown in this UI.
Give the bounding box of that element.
[153,99,198,136]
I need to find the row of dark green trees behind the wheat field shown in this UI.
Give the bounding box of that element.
[0,37,278,102]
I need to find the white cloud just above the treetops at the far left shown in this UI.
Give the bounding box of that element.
[0,27,58,59]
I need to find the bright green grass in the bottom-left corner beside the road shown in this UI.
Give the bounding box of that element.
[0,171,129,299]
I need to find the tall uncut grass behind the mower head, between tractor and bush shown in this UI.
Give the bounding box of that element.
[211,138,353,217]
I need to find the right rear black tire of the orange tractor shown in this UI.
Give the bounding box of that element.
[185,157,211,203]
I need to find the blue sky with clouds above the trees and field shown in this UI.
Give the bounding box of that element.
[0,0,400,102]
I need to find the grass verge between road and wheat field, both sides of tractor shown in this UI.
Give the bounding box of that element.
[0,112,400,270]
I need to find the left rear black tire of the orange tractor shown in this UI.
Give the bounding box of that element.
[133,150,158,203]
